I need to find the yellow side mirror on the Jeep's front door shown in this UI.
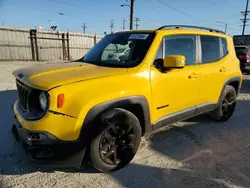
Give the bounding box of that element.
[163,55,186,69]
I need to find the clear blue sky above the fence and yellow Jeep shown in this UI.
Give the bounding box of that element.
[0,0,247,35]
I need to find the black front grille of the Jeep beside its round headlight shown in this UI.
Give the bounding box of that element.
[16,81,31,111]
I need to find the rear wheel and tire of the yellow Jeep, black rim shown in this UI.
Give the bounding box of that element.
[210,85,236,122]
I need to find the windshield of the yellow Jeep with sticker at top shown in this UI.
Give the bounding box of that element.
[83,33,154,67]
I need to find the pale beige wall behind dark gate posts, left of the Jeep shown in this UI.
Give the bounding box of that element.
[0,27,103,61]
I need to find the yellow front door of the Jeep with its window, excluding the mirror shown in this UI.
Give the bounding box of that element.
[151,35,201,125]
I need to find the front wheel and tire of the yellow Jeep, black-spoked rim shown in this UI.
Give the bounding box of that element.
[90,108,142,172]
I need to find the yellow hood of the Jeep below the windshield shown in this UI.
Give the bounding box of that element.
[13,62,127,90]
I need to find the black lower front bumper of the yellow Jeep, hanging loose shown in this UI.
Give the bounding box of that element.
[12,118,86,167]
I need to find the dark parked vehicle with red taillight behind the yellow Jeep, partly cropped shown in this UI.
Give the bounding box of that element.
[234,45,250,74]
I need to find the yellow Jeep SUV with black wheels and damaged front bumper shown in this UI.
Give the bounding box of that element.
[12,25,242,172]
